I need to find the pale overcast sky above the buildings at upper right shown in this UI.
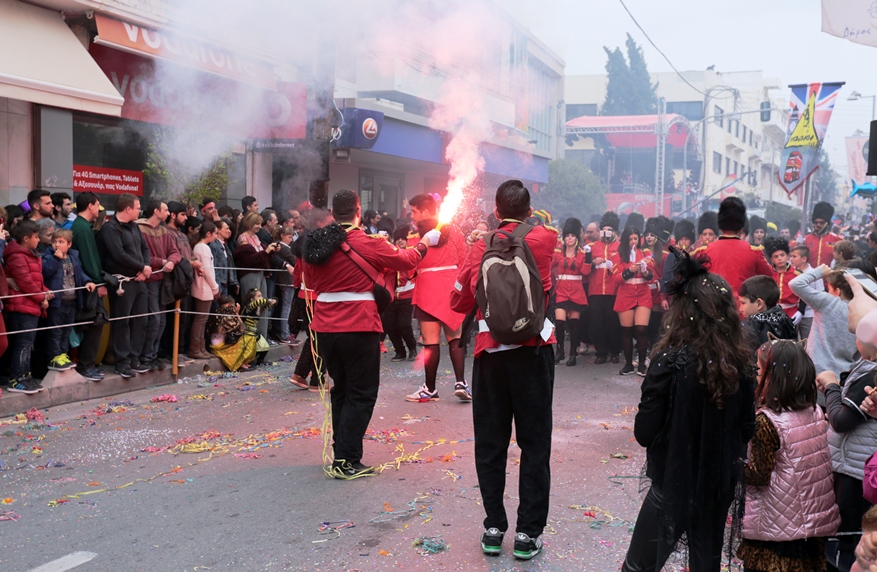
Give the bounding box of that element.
[498,0,877,181]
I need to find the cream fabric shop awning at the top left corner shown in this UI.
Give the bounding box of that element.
[0,0,124,116]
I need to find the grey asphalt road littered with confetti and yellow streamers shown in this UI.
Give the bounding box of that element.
[0,348,645,572]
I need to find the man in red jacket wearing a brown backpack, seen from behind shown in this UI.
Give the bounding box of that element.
[451,180,557,560]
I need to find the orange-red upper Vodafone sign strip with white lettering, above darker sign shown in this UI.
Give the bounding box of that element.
[94,14,275,90]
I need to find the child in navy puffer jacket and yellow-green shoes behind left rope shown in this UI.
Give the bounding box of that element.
[43,229,95,371]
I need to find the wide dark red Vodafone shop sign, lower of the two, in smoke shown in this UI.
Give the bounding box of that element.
[89,44,307,139]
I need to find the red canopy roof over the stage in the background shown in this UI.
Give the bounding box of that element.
[566,113,696,149]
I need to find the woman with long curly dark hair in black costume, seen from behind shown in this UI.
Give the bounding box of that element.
[621,250,755,572]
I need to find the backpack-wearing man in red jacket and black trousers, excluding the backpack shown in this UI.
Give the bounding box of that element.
[452,180,556,559]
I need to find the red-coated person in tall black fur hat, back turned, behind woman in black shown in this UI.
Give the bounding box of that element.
[695,197,773,296]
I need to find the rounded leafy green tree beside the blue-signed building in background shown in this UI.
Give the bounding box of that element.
[533,159,606,222]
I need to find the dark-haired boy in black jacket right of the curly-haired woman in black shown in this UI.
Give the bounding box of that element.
[739,276,798,348]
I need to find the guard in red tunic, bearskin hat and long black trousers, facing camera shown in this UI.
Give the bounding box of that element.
[585,211,621,364]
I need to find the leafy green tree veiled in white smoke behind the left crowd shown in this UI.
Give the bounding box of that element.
[143,125,231,205]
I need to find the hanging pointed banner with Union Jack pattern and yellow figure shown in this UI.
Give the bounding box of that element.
[777,82,843,197]
